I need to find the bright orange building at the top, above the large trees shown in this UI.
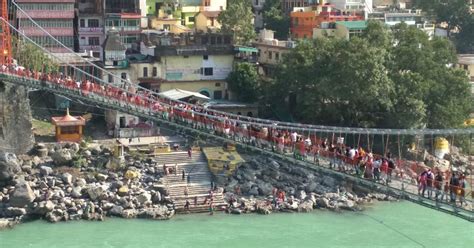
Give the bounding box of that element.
[290,4,364,39]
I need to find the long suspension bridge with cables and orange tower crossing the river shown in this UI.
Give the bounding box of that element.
[0,0,474,221]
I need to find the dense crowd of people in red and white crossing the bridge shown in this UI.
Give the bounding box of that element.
[0,64,466,207]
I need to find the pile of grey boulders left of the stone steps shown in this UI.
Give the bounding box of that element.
[0,144,174,231]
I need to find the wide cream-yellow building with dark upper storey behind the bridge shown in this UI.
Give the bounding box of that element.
[137,33,234,99]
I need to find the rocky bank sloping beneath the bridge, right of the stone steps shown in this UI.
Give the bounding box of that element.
[218,157,396,214]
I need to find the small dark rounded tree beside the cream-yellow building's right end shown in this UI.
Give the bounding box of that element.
[227,62,261,102]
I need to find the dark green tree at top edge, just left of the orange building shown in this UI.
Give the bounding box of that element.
[263,0,290,40]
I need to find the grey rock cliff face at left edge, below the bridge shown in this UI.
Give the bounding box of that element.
[0,82,34,154]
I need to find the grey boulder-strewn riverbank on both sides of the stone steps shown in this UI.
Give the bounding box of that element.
[0,144,394,232]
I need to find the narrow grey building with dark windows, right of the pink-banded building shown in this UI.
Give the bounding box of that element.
[78,0,105,58]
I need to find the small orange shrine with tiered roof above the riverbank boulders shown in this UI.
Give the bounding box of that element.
[52,108,86,142]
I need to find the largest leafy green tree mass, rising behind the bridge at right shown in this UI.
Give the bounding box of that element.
[267,23,474,128]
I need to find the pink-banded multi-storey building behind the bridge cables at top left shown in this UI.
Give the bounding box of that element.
[16,0,76,52]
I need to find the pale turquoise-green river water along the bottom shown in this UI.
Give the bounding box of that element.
[0,202,474,248]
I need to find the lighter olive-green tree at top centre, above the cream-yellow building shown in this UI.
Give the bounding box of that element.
[217,0,255,45]
